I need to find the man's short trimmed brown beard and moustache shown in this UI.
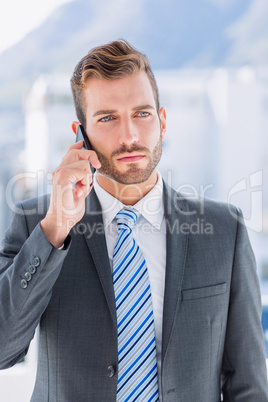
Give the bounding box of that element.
[94,135,162,185]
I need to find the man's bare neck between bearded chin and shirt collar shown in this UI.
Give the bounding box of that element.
[95,170,157,205]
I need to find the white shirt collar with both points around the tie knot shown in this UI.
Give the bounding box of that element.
[94,172,164,230]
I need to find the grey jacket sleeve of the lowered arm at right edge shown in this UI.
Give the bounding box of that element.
[222,211,268,402]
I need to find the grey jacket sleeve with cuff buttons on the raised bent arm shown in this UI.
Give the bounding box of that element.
[0,205,70,369]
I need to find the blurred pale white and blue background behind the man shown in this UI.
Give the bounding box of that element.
[0,0,268,402]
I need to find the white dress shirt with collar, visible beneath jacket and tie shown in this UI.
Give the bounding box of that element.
[94,172,166,401]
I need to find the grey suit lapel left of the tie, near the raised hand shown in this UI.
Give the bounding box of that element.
[82,189,117,328]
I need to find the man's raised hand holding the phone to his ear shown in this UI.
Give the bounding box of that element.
[41,141,101,248]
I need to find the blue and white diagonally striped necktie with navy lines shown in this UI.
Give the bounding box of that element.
[113,207,159,402]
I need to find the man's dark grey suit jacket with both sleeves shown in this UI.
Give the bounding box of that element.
[0,184,268,402]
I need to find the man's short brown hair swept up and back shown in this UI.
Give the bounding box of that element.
[71,39,160,127]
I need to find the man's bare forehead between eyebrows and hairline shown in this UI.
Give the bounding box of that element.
[84,71,156,111]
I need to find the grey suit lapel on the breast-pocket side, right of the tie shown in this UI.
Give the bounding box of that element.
[162,182,188,362]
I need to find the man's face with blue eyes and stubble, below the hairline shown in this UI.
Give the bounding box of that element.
[84,72,166,184]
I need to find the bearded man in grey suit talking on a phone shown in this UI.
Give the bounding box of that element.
[0,41,268,402]
